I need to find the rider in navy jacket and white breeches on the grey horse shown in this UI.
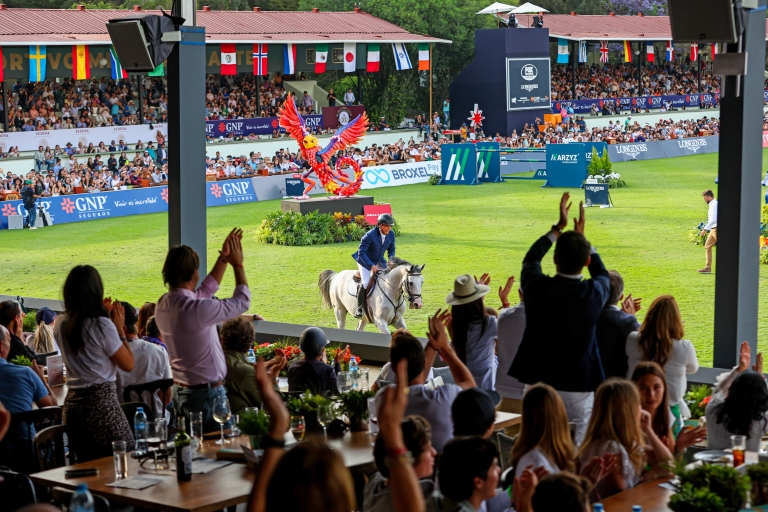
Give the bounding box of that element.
[352,213,395,318]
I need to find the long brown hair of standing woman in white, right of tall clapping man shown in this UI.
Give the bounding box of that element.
[637,295,685,368]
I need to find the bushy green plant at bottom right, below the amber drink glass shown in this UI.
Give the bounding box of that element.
[669,464,750,512]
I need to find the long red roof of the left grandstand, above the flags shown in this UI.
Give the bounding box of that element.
[0,9,451,45]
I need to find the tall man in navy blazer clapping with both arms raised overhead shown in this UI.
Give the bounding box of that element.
[509,192,610,443]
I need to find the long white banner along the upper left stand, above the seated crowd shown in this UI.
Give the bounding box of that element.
[0,124,168,152]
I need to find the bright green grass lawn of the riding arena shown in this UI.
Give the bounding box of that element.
[0,150,768,365]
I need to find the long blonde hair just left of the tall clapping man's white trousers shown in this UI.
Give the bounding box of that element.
[511,383,576,472]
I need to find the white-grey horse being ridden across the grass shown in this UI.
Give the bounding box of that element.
[317,258,424,334]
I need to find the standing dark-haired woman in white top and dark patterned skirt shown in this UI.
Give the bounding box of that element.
[55,265,134,462]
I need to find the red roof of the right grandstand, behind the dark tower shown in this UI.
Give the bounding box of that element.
[504,14,768,41]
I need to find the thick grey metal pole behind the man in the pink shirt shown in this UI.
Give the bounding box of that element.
[167,24,208,279]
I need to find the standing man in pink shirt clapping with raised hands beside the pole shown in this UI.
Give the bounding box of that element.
[155,228,251,432]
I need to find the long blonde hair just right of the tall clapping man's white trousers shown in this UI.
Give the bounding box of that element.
[578,377,646,475]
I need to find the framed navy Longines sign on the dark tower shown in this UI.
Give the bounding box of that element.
[507,57,559,112]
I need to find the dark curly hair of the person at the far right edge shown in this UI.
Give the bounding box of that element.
[715,370,768,438]
